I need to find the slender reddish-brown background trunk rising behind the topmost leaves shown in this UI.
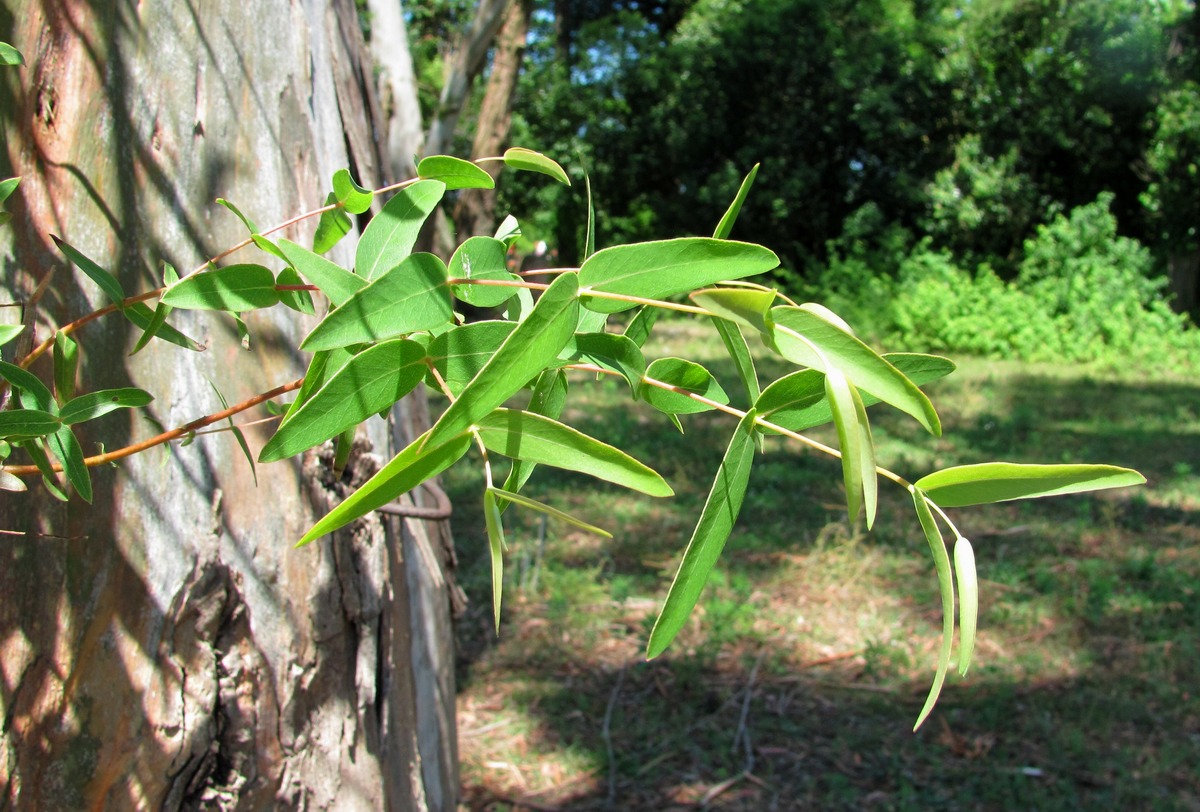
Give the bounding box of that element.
[454,0,533,242]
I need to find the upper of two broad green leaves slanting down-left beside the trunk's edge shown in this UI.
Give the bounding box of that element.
[300,253,454,353]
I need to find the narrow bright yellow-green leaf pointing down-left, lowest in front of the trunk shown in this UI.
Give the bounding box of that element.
[296,432,470,547]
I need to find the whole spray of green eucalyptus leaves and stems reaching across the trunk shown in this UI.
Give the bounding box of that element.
[0,41,1144,726]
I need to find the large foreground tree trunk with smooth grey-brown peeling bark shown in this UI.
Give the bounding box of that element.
[0,0,457,811]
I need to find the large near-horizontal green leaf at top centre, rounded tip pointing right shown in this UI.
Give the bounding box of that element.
[580,237,779,313]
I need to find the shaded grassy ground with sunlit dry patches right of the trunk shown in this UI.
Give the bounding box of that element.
[446,325,1200,811]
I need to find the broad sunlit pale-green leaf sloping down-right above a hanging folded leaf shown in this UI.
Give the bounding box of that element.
[770,306,942,435]
